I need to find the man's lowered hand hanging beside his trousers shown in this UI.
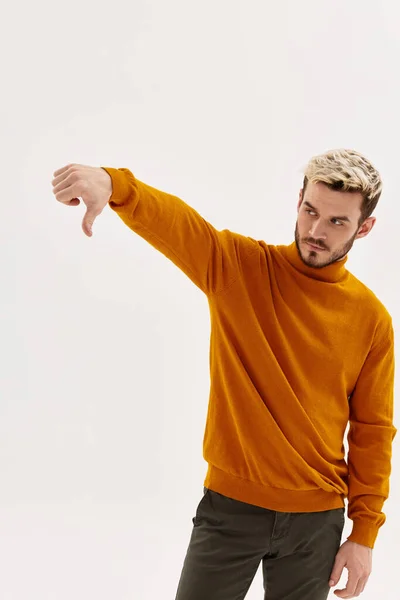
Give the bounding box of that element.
[329,540,372,598]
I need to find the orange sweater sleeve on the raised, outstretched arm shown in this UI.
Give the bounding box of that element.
[102,167,258,295]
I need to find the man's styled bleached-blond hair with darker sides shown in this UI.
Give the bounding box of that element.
[303,148,382,226]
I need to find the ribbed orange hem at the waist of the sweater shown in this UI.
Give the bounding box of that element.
[204,465,345,512]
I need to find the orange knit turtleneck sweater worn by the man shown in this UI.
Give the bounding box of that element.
[103,167,397,548]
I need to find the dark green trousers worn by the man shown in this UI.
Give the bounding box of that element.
[175,488,345,600]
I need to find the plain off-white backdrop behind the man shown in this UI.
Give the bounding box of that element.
[0,0,400,600]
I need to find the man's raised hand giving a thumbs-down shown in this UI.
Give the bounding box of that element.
[52,164,113,237]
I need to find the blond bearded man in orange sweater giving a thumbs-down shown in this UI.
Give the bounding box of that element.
[52,149,397,600]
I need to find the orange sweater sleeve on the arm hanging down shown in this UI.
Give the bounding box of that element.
[348,319,397,548]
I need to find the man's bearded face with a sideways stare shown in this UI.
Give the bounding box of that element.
[295,183,376,269]
